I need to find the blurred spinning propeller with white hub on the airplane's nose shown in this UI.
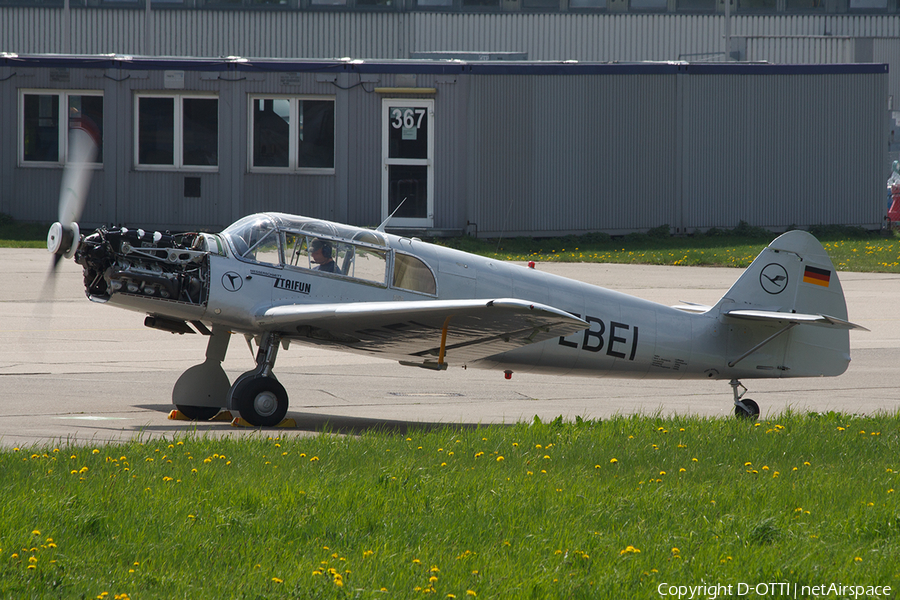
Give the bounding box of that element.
[47,125,98,277]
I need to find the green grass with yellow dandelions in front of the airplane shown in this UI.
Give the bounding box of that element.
[0,413,900,599]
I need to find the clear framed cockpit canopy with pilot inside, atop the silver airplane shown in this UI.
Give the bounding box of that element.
[222,213,437,295]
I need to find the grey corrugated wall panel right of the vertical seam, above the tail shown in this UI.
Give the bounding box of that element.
[680,75,885,228]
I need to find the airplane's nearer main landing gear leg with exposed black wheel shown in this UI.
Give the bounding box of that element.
[226,333,288,427]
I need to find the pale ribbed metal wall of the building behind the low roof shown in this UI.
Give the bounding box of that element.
[0,7,900,62]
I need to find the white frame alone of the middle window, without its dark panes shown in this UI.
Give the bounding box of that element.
[132,91,221,173]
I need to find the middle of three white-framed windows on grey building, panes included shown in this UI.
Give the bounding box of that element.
[135,94,219,171]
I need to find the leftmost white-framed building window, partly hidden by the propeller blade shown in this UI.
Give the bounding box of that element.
[19,90,103,166]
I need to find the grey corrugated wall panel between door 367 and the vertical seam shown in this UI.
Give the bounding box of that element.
[470,75,677,235]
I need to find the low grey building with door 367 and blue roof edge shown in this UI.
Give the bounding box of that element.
[0,55,889,237]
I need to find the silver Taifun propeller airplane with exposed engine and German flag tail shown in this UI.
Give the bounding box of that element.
[48,131,864,426]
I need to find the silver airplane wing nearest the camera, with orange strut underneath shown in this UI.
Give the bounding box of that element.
[256,298,588,369]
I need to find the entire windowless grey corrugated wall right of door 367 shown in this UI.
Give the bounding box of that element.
[471,65,886,236]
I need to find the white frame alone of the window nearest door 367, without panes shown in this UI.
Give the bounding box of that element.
[247,93,337,175]
